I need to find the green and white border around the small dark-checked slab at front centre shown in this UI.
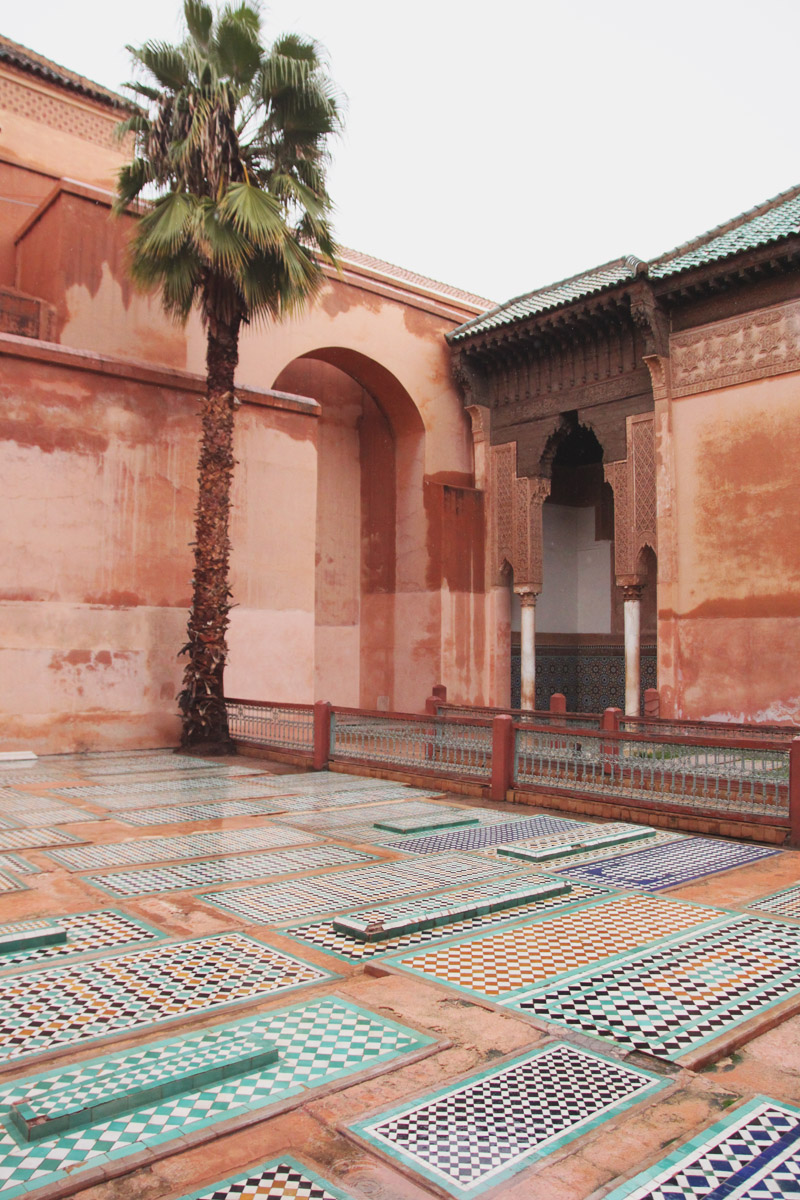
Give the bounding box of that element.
[347,1039,674,1200]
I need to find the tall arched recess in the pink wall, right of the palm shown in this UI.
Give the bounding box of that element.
[272,347,431,708]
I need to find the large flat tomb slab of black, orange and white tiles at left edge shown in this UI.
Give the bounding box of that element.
[0,934,331,1061]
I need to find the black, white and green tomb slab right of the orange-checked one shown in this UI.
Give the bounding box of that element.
[504,916,800,1060]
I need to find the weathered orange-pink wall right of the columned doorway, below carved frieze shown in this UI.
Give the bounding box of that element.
[656,364,800,722]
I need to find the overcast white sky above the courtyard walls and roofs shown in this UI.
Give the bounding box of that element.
[0,0,800,300]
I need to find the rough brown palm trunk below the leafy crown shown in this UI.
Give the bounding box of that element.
[178,319,239,754]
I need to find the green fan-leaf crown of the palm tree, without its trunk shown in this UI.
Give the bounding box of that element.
[116,0,341,323]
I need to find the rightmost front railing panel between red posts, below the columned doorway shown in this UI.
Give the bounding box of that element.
[515,725,789,821]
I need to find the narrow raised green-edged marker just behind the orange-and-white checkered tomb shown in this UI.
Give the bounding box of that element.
[333,875,570,942]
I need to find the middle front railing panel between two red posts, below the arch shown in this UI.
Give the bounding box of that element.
[331,708,492,780]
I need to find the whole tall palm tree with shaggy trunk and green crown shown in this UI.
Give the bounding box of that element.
[115,0,341,750]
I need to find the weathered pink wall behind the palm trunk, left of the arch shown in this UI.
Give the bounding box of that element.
[0,336,315,752]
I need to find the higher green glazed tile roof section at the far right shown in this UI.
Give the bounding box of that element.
[648,187,800,280]
